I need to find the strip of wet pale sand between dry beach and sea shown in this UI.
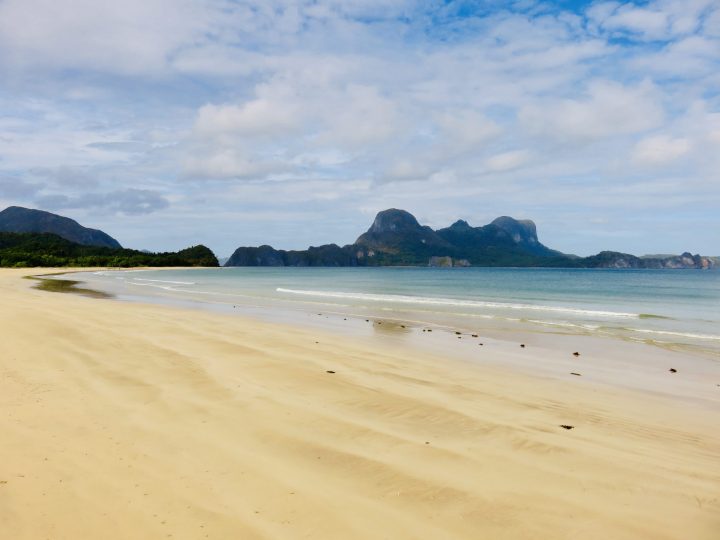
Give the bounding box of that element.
[43,268,720,406]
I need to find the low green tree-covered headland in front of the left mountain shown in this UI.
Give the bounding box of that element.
[0,232,219,268]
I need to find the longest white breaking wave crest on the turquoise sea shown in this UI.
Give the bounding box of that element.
[275,287,640,319]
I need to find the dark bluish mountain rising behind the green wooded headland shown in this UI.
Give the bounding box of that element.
[0,206,122,249]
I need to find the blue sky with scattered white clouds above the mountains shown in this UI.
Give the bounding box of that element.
[0,0,720,256]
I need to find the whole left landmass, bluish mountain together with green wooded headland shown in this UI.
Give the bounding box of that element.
[0,206,219,268]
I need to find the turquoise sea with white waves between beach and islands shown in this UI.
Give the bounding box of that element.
[79,268,720,354]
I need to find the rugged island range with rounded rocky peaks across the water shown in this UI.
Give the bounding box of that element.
[225,208,716,268]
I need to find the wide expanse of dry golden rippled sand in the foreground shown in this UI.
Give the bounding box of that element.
[0,269,720,540]
